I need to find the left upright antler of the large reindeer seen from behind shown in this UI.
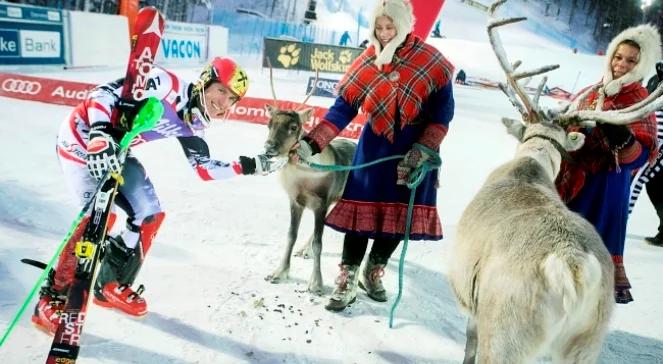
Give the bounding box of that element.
[487,0,559,123]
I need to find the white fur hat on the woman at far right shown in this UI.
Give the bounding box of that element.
[603,24,661,96]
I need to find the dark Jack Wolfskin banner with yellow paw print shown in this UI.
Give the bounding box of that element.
[262,38,364,73]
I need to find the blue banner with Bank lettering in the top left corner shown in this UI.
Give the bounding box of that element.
[0,3,64,65]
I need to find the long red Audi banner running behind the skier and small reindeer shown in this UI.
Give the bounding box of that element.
[0,73,366,139]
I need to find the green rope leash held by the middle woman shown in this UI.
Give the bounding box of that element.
[302,143,442,328]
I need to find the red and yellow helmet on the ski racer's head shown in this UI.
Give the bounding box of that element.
[193,57,249,98]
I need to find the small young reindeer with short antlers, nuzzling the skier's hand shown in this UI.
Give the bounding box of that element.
[265,67,357,295]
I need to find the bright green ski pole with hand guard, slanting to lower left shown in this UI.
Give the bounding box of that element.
[0,97,164,347]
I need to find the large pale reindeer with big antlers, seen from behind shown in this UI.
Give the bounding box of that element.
[449,0,663,363]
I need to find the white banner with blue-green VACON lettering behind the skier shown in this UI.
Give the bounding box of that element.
[156,22,208,65]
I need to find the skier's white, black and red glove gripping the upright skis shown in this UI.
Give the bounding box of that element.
[87,123,122,180]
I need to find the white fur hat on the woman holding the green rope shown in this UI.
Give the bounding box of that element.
[369,0,414,69]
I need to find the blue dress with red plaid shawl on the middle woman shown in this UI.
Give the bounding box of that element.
[305,34,454,240]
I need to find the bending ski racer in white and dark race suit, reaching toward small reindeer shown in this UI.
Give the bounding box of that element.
[32,57,278,333]
